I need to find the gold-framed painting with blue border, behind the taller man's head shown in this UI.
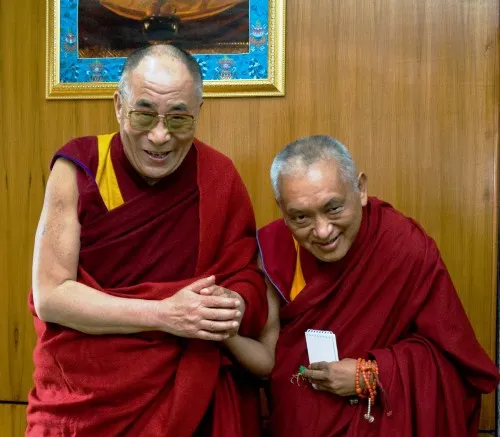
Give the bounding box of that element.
[46,0,286,99]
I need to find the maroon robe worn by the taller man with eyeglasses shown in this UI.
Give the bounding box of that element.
[27,136,267,437]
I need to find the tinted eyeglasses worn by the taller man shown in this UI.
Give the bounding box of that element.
[127,109,194,134]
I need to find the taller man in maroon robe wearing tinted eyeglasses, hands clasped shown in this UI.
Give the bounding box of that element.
[27,45,267,437]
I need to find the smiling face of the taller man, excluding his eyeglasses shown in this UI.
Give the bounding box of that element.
[114,57,201,184]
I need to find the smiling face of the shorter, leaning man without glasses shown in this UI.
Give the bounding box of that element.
[278,159,367,262]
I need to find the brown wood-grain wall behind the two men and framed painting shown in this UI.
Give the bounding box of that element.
[0,0,499,436]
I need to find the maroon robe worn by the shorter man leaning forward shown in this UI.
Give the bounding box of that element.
[258,198,499,437]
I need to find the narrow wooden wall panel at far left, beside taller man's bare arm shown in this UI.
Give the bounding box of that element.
[0,0,44,402]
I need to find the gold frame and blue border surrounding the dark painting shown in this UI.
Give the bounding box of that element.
[46,0,286,99]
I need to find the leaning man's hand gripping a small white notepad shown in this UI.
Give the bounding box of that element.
[302,329,356,396]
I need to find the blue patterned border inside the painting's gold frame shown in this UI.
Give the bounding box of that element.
[58,0,269,84]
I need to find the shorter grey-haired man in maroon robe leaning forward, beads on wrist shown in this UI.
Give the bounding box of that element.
[258,136,499,437]
